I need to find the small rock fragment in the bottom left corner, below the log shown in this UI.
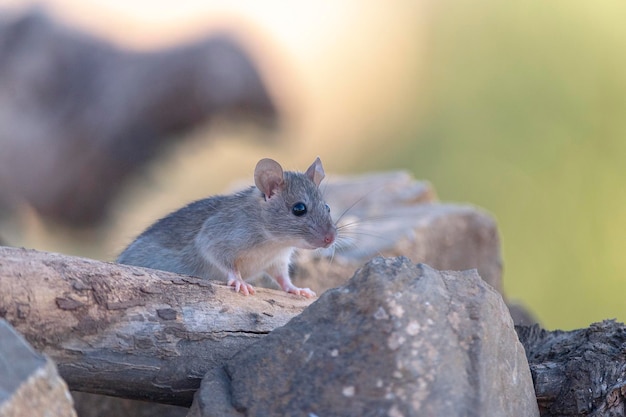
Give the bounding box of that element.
[0,319,76,417]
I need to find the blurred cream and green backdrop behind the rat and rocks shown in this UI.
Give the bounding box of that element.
[0,0,626,329]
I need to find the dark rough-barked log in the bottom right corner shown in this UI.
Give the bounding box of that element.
[516,320,626,417]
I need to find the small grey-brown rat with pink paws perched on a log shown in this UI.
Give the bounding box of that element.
[117,157,337,297]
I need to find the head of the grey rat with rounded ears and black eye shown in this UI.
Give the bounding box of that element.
[254,158,337,249]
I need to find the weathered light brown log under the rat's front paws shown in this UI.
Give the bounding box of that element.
[0,247,312,406]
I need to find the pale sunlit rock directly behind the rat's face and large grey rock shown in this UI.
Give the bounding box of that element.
[293,172,502,294]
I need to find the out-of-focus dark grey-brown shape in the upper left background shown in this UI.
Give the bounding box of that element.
[0,11,278,227]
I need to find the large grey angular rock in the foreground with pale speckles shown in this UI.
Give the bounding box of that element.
[189,257,539,417]
